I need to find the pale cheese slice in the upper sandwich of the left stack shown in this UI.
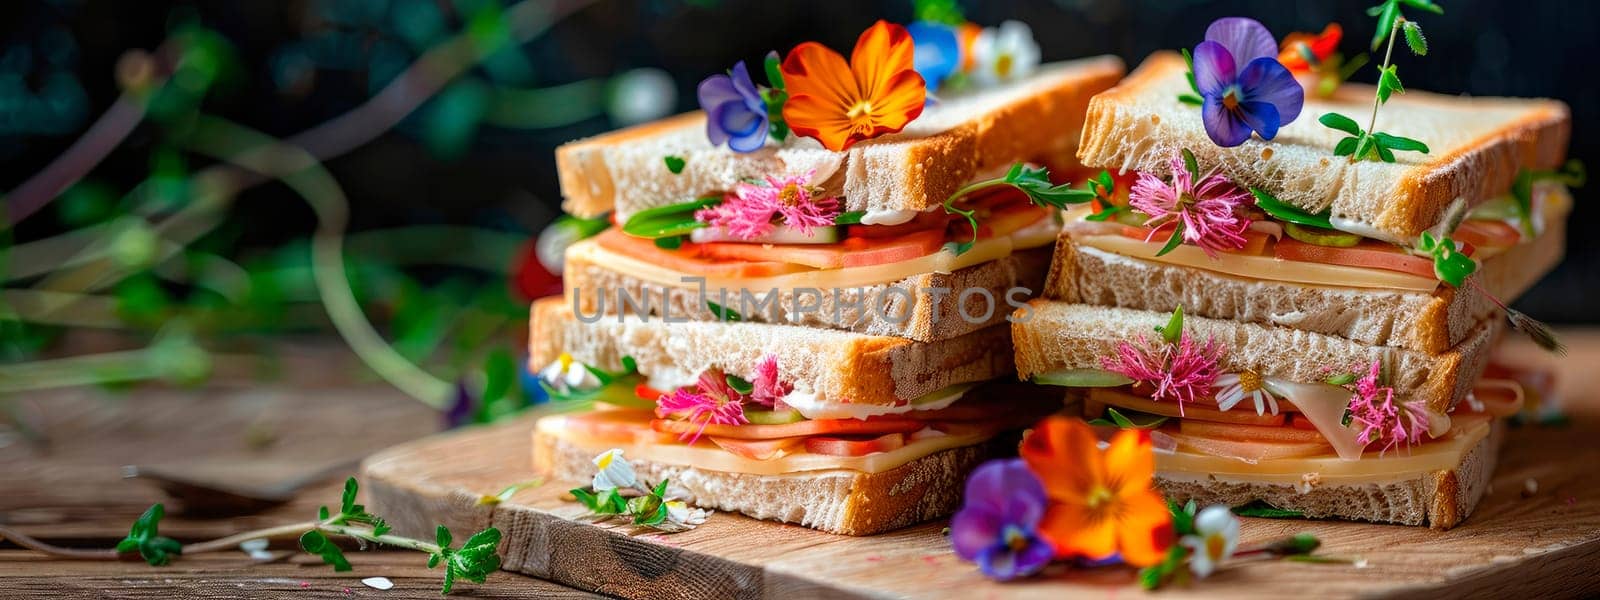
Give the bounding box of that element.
[566,218,1059,296]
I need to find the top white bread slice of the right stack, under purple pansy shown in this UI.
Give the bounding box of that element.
[1078,53,1571,243]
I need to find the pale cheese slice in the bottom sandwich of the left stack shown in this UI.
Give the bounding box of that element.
[534,414,990,477]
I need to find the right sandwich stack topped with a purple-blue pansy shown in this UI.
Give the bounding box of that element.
[1013,36,1571,528]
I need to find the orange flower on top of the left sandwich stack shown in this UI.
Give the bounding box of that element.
[782,21,928,150]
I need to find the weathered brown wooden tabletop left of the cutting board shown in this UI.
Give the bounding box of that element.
[0,344,597,598]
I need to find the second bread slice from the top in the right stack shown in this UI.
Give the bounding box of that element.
[1042,190,1566,354]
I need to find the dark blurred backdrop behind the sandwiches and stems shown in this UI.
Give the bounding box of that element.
[9,0,1600,323]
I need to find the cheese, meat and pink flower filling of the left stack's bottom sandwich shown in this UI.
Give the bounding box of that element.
[539,355,1059,475]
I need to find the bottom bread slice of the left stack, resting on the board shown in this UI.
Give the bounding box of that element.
[533,427,1016,536]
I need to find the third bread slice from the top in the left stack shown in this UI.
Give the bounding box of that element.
[528,298,1013,405]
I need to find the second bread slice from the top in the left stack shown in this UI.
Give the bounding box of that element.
[565,248,1053,342]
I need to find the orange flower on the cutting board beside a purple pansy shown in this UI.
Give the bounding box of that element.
[1022,416,1173,566]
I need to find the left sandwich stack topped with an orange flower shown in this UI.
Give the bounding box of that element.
[530,22,1123,534]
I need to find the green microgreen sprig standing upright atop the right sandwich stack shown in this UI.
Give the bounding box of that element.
[1317,0,1445,163]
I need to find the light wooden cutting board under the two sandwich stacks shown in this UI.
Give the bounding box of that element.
[363,334,1600,600]
